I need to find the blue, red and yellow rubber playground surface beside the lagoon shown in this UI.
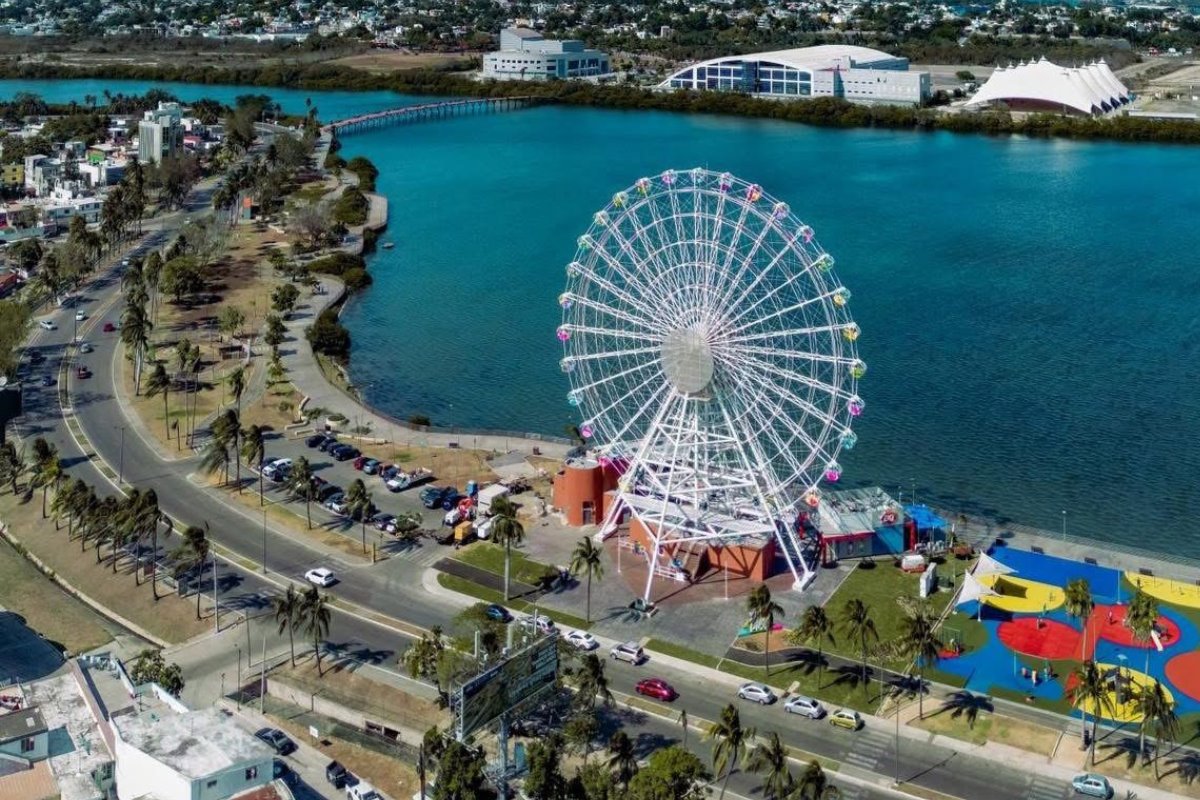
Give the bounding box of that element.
[937,547,1200,722]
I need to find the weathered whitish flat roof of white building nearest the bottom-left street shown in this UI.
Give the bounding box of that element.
[113,698,274,778]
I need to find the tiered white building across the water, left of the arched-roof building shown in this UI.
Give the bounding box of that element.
[484,28,612,80]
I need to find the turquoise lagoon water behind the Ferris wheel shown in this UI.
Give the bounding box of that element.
[0,82,1200,557]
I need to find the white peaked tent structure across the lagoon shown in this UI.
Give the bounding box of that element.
[966,56,1129,115]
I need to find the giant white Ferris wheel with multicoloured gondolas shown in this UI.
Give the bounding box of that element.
[557,168,866,600]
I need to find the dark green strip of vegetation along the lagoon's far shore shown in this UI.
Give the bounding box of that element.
[7,62,1200,144]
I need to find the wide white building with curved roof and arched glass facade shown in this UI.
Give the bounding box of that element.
[659,44,931,106]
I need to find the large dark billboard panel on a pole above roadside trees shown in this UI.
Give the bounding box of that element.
[454,636,558,736]
